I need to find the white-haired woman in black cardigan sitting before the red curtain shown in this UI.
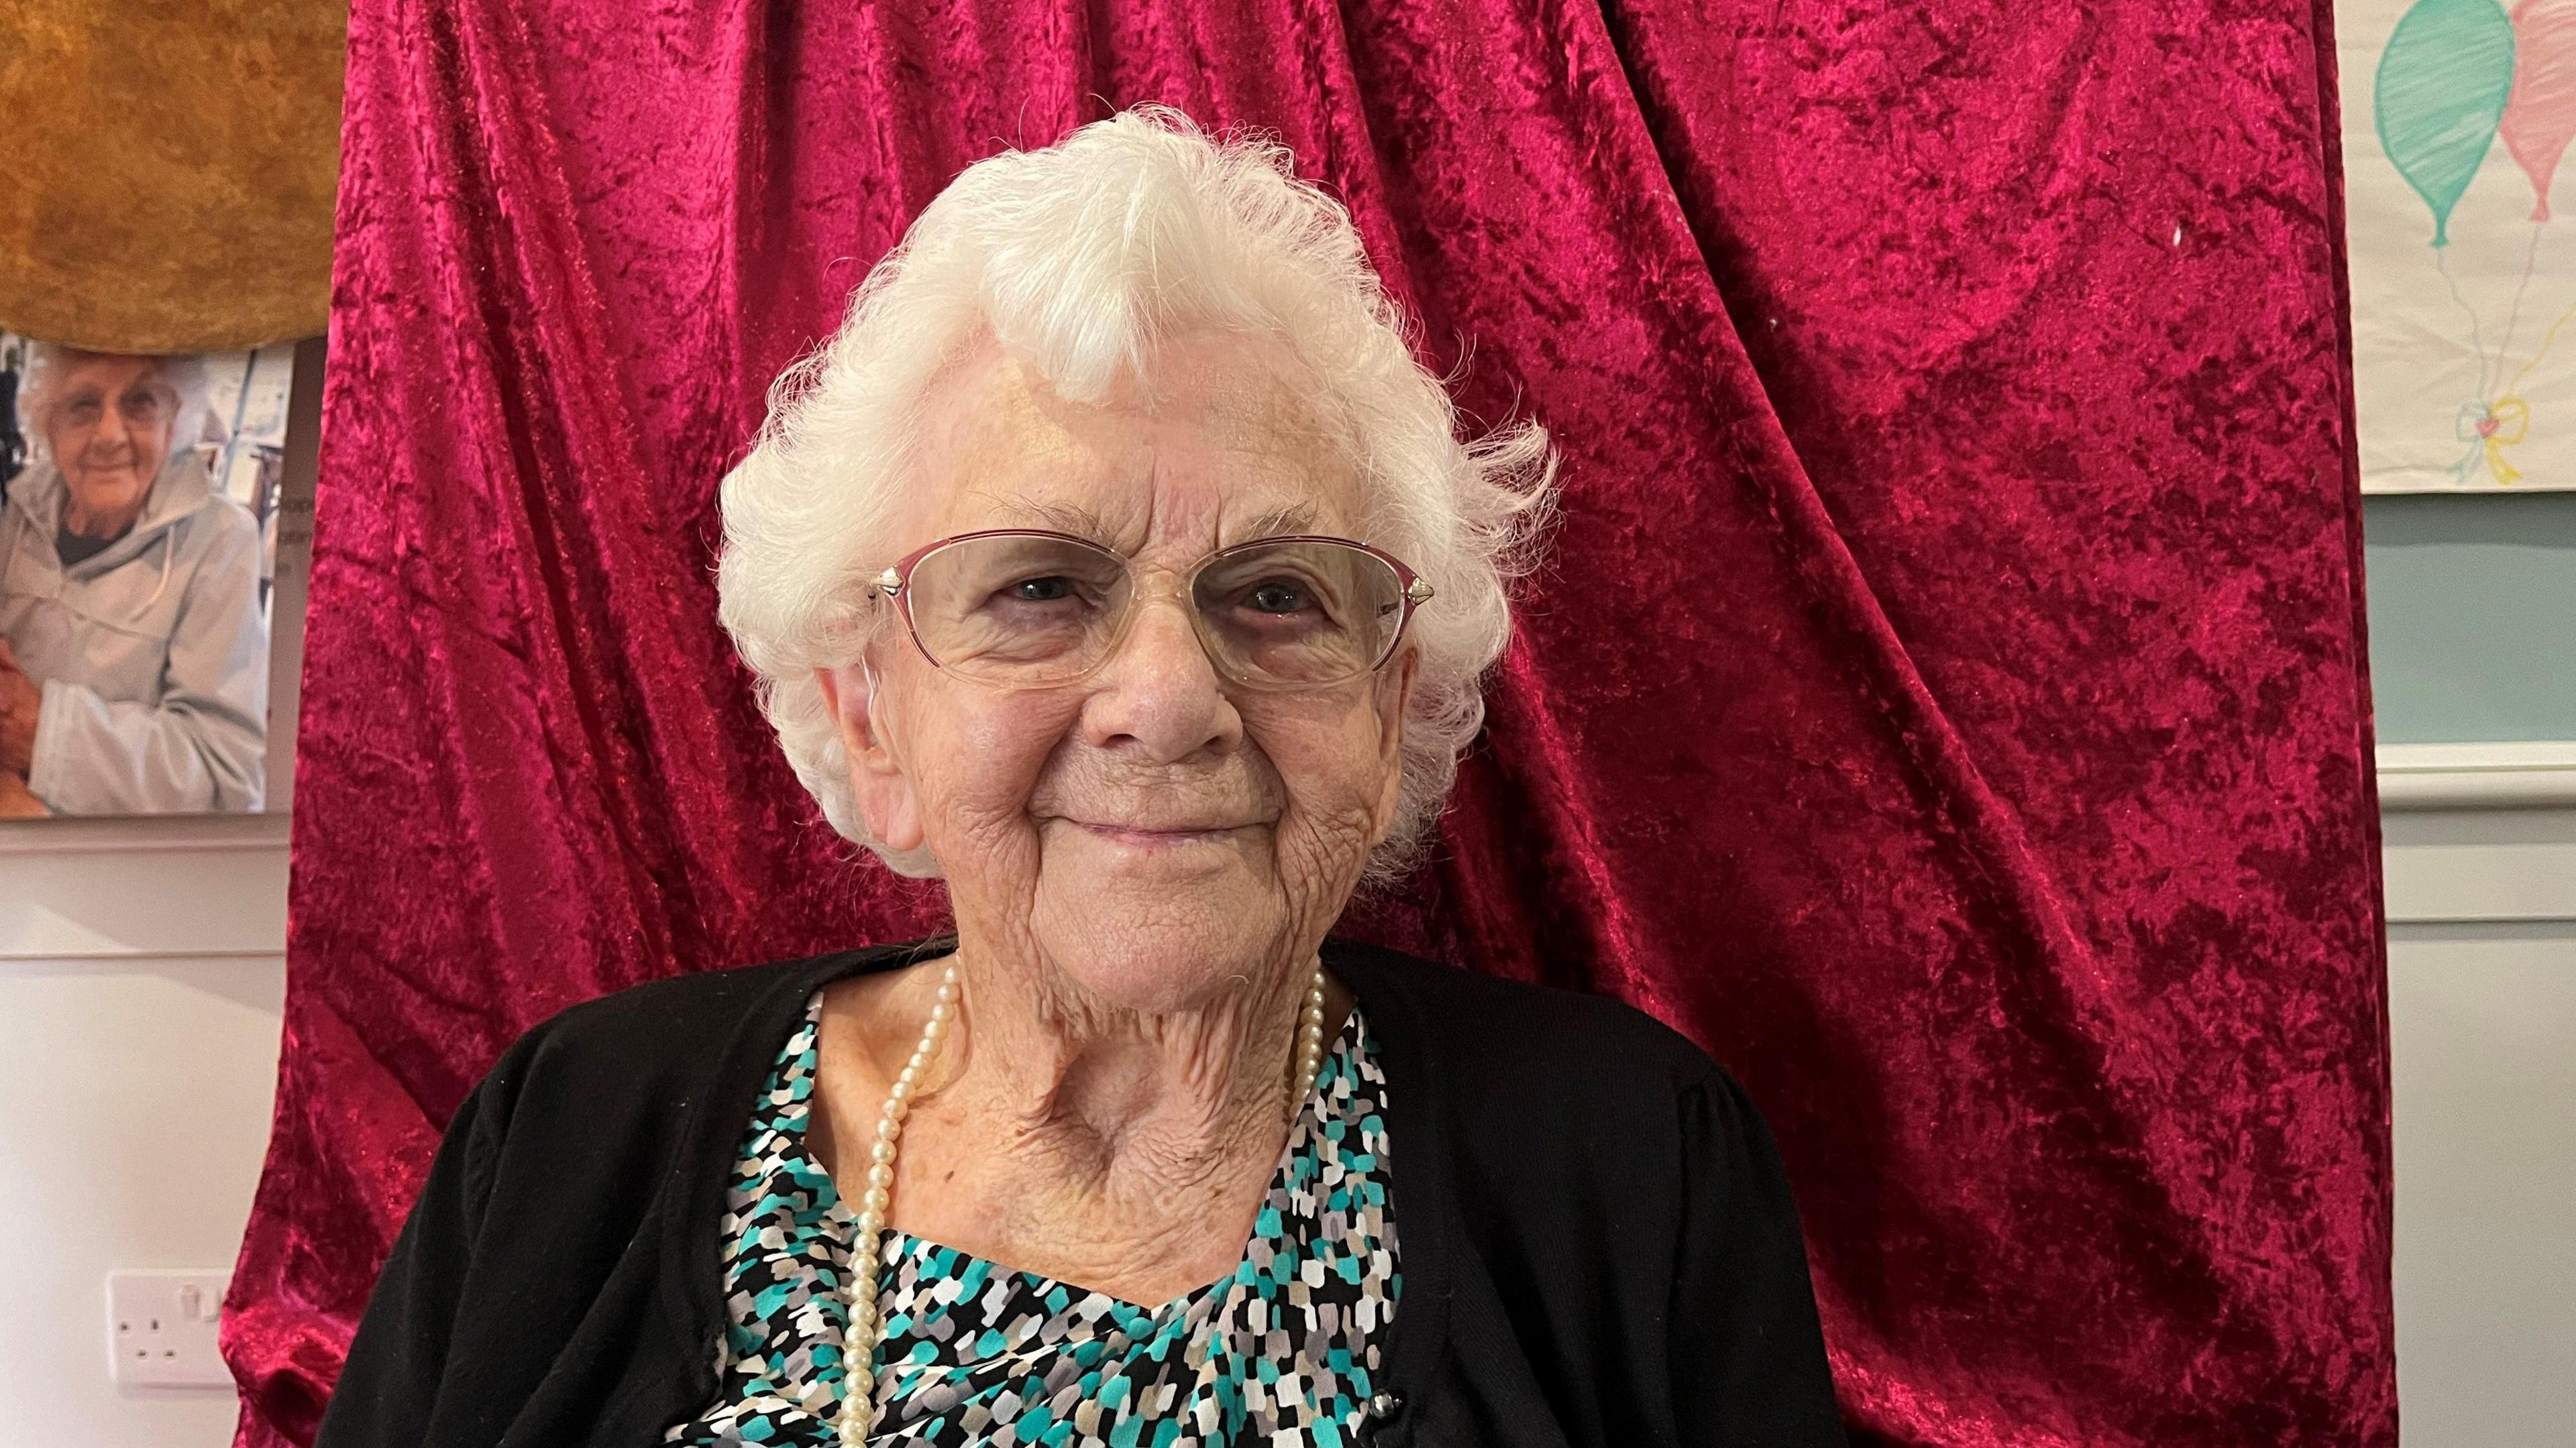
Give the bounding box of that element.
[319,113,1842,1448]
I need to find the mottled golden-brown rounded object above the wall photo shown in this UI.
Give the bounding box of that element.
[0,0,347,353]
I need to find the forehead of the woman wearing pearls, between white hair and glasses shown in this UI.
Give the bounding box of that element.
[904,335,1365,557]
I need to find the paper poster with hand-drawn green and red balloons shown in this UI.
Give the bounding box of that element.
[2334,0,2576,492]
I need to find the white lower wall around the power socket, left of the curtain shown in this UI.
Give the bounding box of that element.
[0,817,286,1448]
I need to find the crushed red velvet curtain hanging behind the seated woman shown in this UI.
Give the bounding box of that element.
[227,0,2396,1448]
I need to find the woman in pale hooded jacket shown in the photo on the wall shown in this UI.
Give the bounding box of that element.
[0,348,268,814]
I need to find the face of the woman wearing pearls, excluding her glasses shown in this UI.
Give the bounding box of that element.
[824,337,1414,1010]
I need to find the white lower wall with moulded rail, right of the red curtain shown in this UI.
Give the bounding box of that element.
[2380,744,2576,1448]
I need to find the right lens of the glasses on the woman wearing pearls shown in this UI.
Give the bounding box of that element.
[1190,539,1404,688]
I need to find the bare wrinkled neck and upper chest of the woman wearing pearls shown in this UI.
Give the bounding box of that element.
[824,936,1347,1304]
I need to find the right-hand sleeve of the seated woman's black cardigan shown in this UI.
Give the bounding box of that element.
[1669,1069,1844,1448]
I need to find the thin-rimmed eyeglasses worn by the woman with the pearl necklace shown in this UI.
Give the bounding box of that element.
[873,528,1432,691]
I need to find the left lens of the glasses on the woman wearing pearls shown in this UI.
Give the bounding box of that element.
[904,533,1128,683]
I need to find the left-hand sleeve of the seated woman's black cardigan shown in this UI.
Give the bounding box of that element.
[314,1072,505,1448]
